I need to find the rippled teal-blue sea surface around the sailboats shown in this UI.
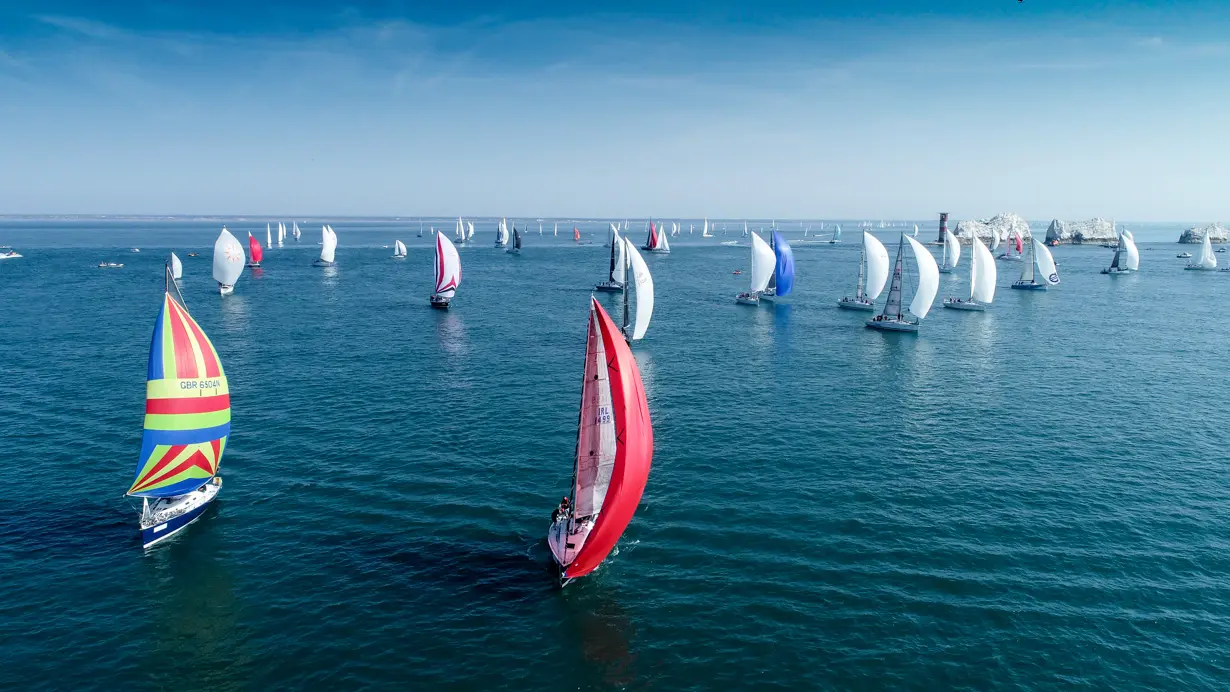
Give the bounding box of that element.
[0,219,1230,691]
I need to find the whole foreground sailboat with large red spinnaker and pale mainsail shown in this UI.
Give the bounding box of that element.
[547,297,653,586]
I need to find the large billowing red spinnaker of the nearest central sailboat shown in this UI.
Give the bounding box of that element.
[563,299,653,579]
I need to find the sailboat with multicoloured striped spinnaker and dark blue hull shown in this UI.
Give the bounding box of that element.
[127,263,231,548]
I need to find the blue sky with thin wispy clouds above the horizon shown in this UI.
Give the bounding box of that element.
[0,0,1230,220]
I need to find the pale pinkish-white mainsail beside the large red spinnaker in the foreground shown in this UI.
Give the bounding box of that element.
[573,306,615,517]
